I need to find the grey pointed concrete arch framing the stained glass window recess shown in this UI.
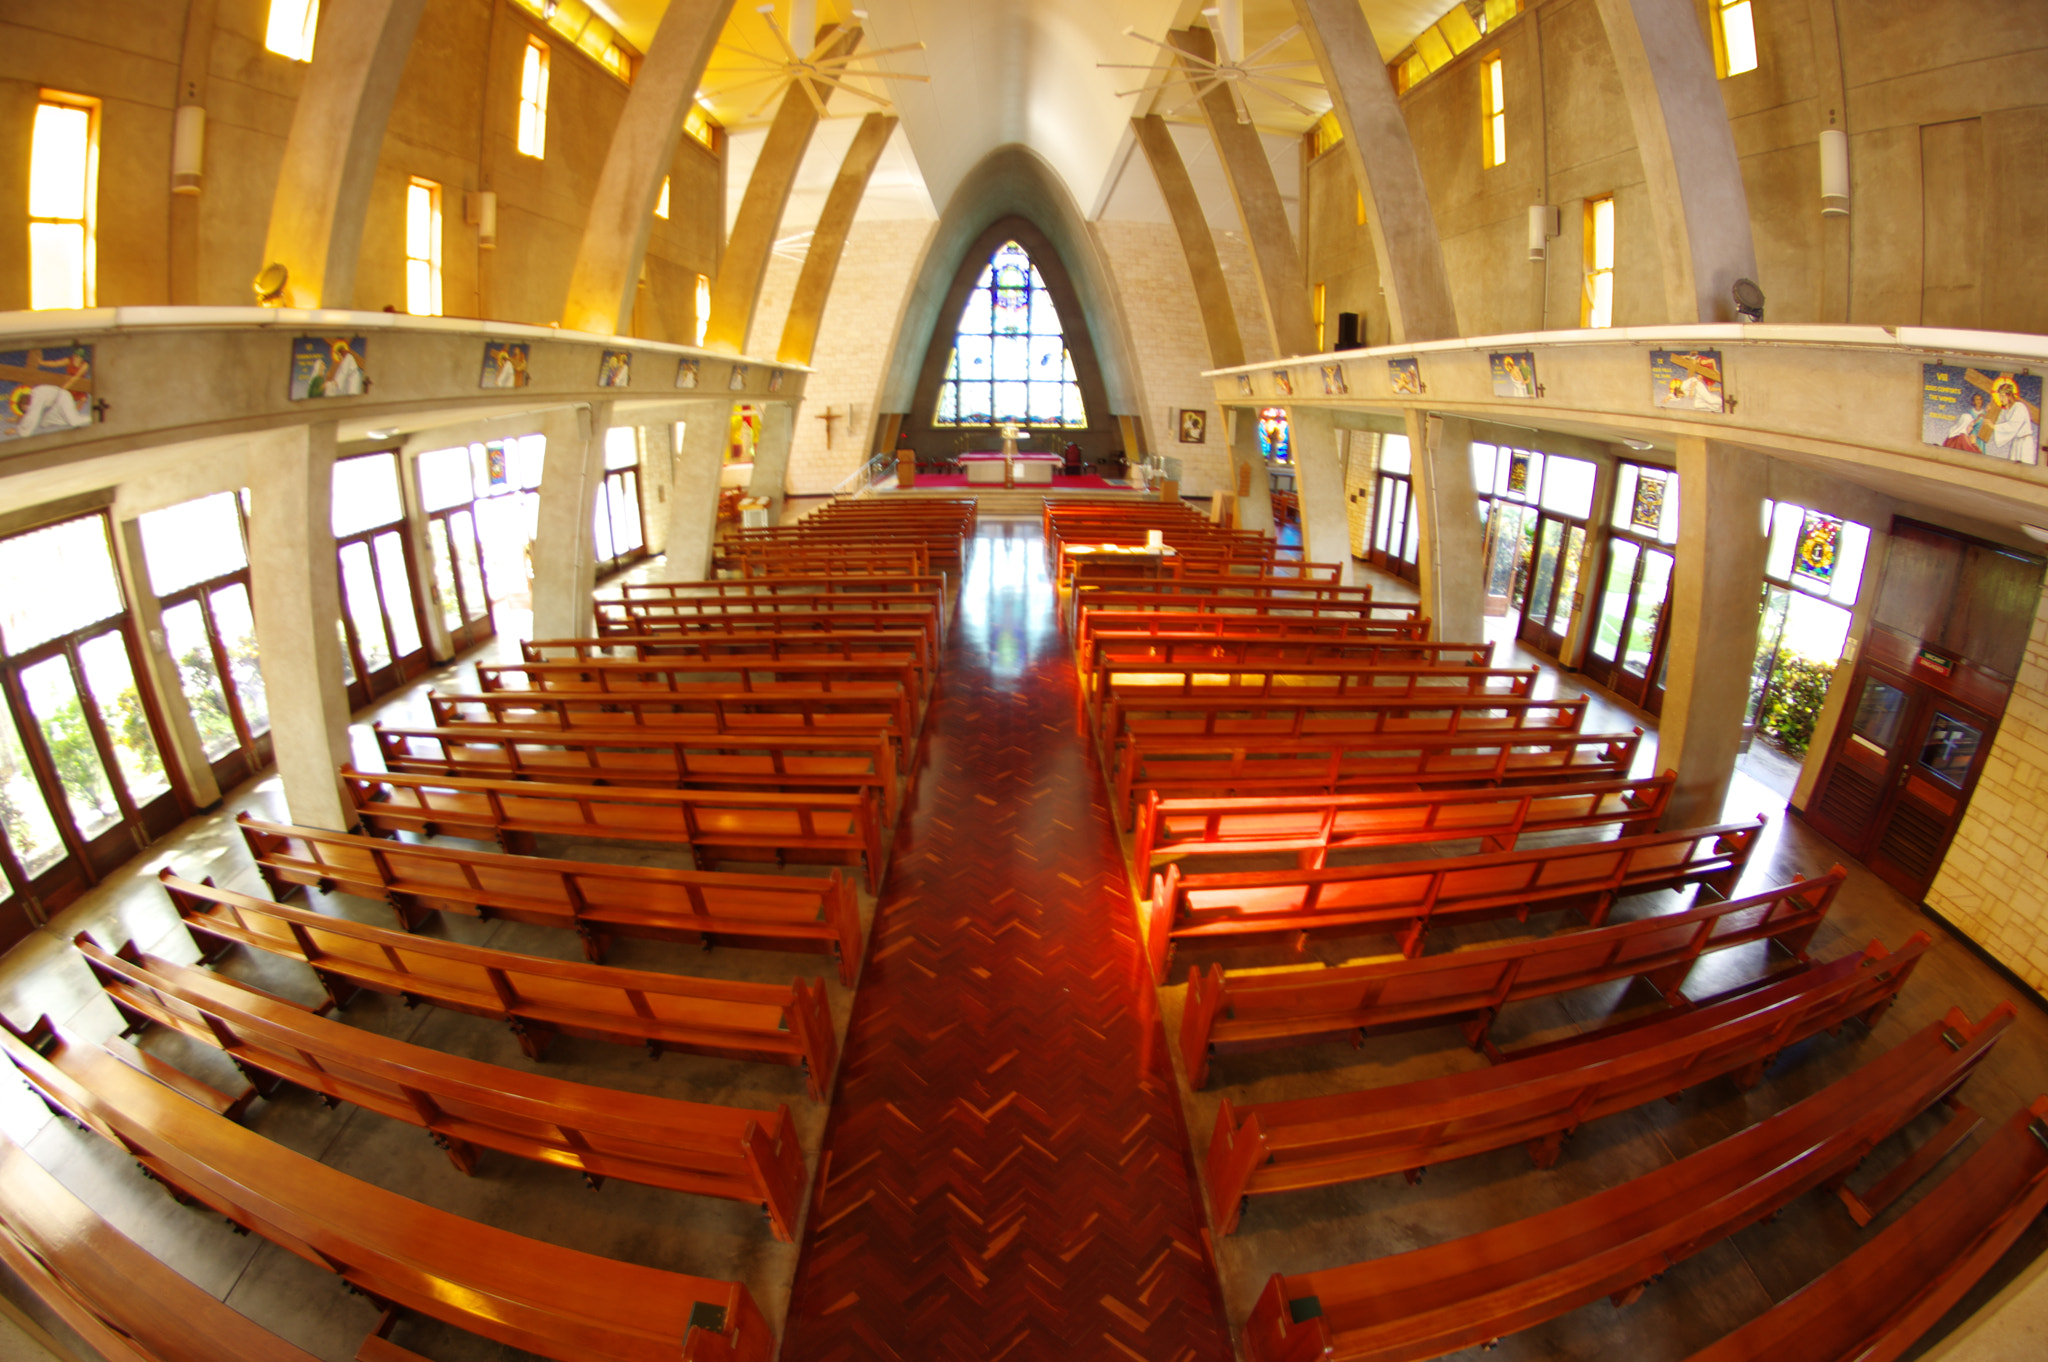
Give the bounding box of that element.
[877,143,1145,424]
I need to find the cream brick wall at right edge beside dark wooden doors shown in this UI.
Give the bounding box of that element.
[1927,596,2048,991]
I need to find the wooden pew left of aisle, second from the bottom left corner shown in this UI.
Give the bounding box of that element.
[0,1018,774,1362]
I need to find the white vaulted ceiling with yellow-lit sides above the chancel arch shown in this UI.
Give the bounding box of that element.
[630,0,1456,236]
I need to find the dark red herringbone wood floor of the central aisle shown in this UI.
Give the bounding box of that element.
[782,520,1231,1362]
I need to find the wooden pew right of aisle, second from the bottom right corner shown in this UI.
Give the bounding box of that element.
[1243,1004,2015,1362]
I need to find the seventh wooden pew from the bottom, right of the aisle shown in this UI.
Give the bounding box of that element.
[1112,729,1642,827]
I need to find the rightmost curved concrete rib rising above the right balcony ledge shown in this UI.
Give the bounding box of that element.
[1589,0,1753,324]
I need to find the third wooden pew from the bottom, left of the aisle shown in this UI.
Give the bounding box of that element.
[72,932,803,1241]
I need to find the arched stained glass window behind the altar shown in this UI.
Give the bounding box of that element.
[932,242,1087,428]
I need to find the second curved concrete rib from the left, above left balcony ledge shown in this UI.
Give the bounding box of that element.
[565,0,733,336]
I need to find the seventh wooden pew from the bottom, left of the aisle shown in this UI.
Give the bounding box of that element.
[371,720,897,819]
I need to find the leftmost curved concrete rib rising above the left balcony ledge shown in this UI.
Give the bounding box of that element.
[260,0,426,307]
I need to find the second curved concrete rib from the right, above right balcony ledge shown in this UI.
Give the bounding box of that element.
[1294,0,1466,346]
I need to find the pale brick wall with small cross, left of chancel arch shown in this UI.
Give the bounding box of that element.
[748,219,934,496]
